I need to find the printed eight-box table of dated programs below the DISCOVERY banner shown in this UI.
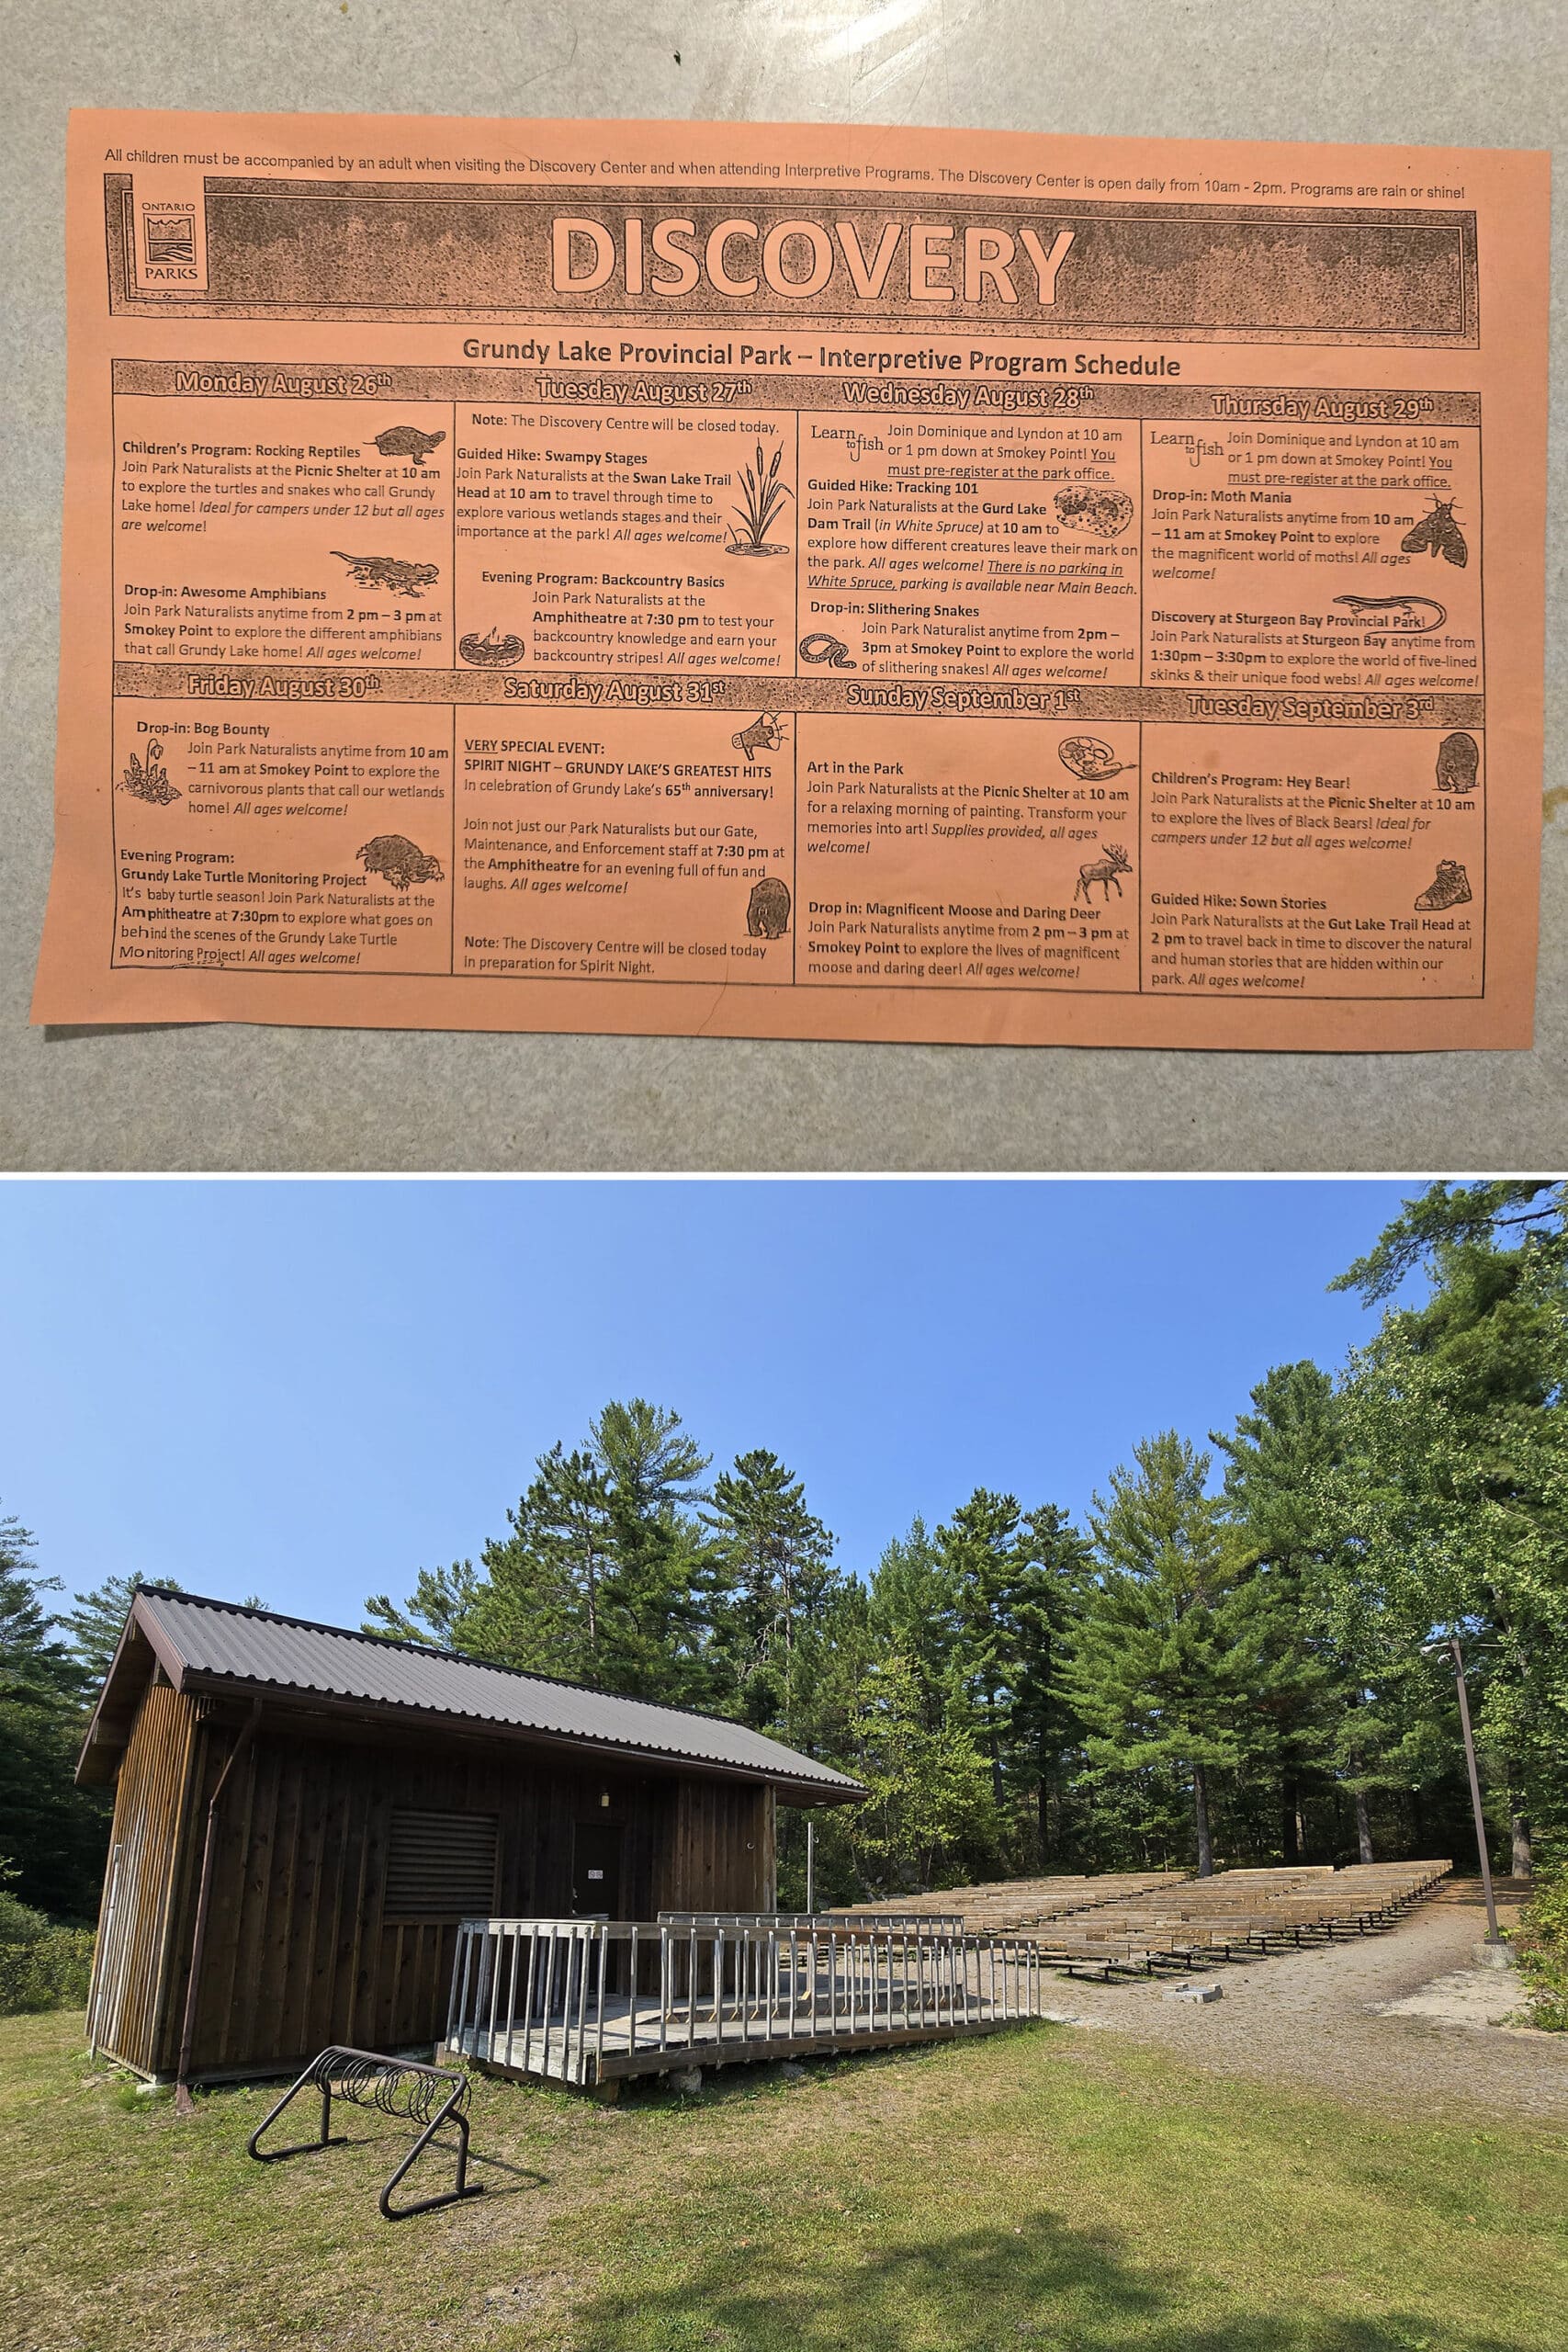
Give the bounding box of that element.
[113,362,1485,1000]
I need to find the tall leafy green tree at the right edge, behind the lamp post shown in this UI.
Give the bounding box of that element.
[1333,1179,1568,1877]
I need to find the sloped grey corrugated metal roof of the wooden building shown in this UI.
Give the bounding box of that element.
[87,1585,861,1804]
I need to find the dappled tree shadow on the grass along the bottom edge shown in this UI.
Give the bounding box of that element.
[571,2211,1540,2352]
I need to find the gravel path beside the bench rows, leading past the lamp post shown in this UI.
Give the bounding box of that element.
[1029,1889,1568,2124]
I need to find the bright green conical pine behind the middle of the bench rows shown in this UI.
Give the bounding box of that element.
[1067,1430,1277,1877]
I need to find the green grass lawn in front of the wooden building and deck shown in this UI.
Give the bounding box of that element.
[0,2013,1568,2352]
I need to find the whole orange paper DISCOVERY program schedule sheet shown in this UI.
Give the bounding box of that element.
[35,113,1547,1049]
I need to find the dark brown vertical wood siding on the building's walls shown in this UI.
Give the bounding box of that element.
[115,1691,771,2075]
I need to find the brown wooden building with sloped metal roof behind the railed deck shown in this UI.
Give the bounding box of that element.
[77,1585,861,2082]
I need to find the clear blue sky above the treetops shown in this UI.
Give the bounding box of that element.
[0,1181,1420,1625]
